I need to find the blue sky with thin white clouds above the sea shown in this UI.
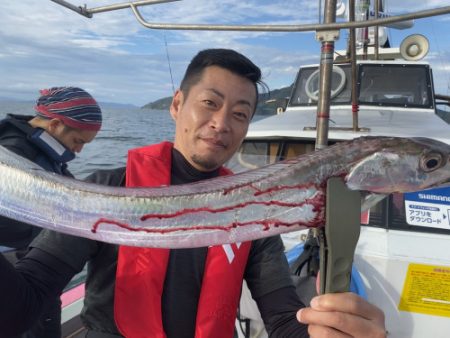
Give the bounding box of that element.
[0,0,450,106]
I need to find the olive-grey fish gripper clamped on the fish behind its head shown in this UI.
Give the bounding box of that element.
[319,177,361,294]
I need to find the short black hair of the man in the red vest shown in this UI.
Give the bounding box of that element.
[180,48,262,115]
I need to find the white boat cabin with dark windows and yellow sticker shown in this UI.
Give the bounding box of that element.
[229,56,450,338]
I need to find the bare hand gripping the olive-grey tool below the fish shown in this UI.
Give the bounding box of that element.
[297,292,387,338]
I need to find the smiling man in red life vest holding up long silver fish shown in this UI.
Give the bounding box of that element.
[0,49,385,338]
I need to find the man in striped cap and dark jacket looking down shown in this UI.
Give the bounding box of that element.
[0,87,102,338]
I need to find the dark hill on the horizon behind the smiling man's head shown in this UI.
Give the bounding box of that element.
[141,85,292,115]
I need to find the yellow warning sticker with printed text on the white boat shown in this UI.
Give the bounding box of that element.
[398,264,450,317]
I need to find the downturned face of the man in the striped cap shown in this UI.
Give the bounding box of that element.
[47,119,97,153]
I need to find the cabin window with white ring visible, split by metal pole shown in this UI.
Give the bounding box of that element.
[289,64,351,106]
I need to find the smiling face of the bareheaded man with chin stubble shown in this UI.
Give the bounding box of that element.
[170,66,256,171]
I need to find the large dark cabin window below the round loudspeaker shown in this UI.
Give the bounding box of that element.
[358,64,433,108]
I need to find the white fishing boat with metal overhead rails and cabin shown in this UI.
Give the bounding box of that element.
[38,0,450,338]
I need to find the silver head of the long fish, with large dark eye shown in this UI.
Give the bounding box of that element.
[345,137,450,194]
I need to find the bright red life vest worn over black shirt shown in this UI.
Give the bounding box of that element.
[114,142,251,338]
